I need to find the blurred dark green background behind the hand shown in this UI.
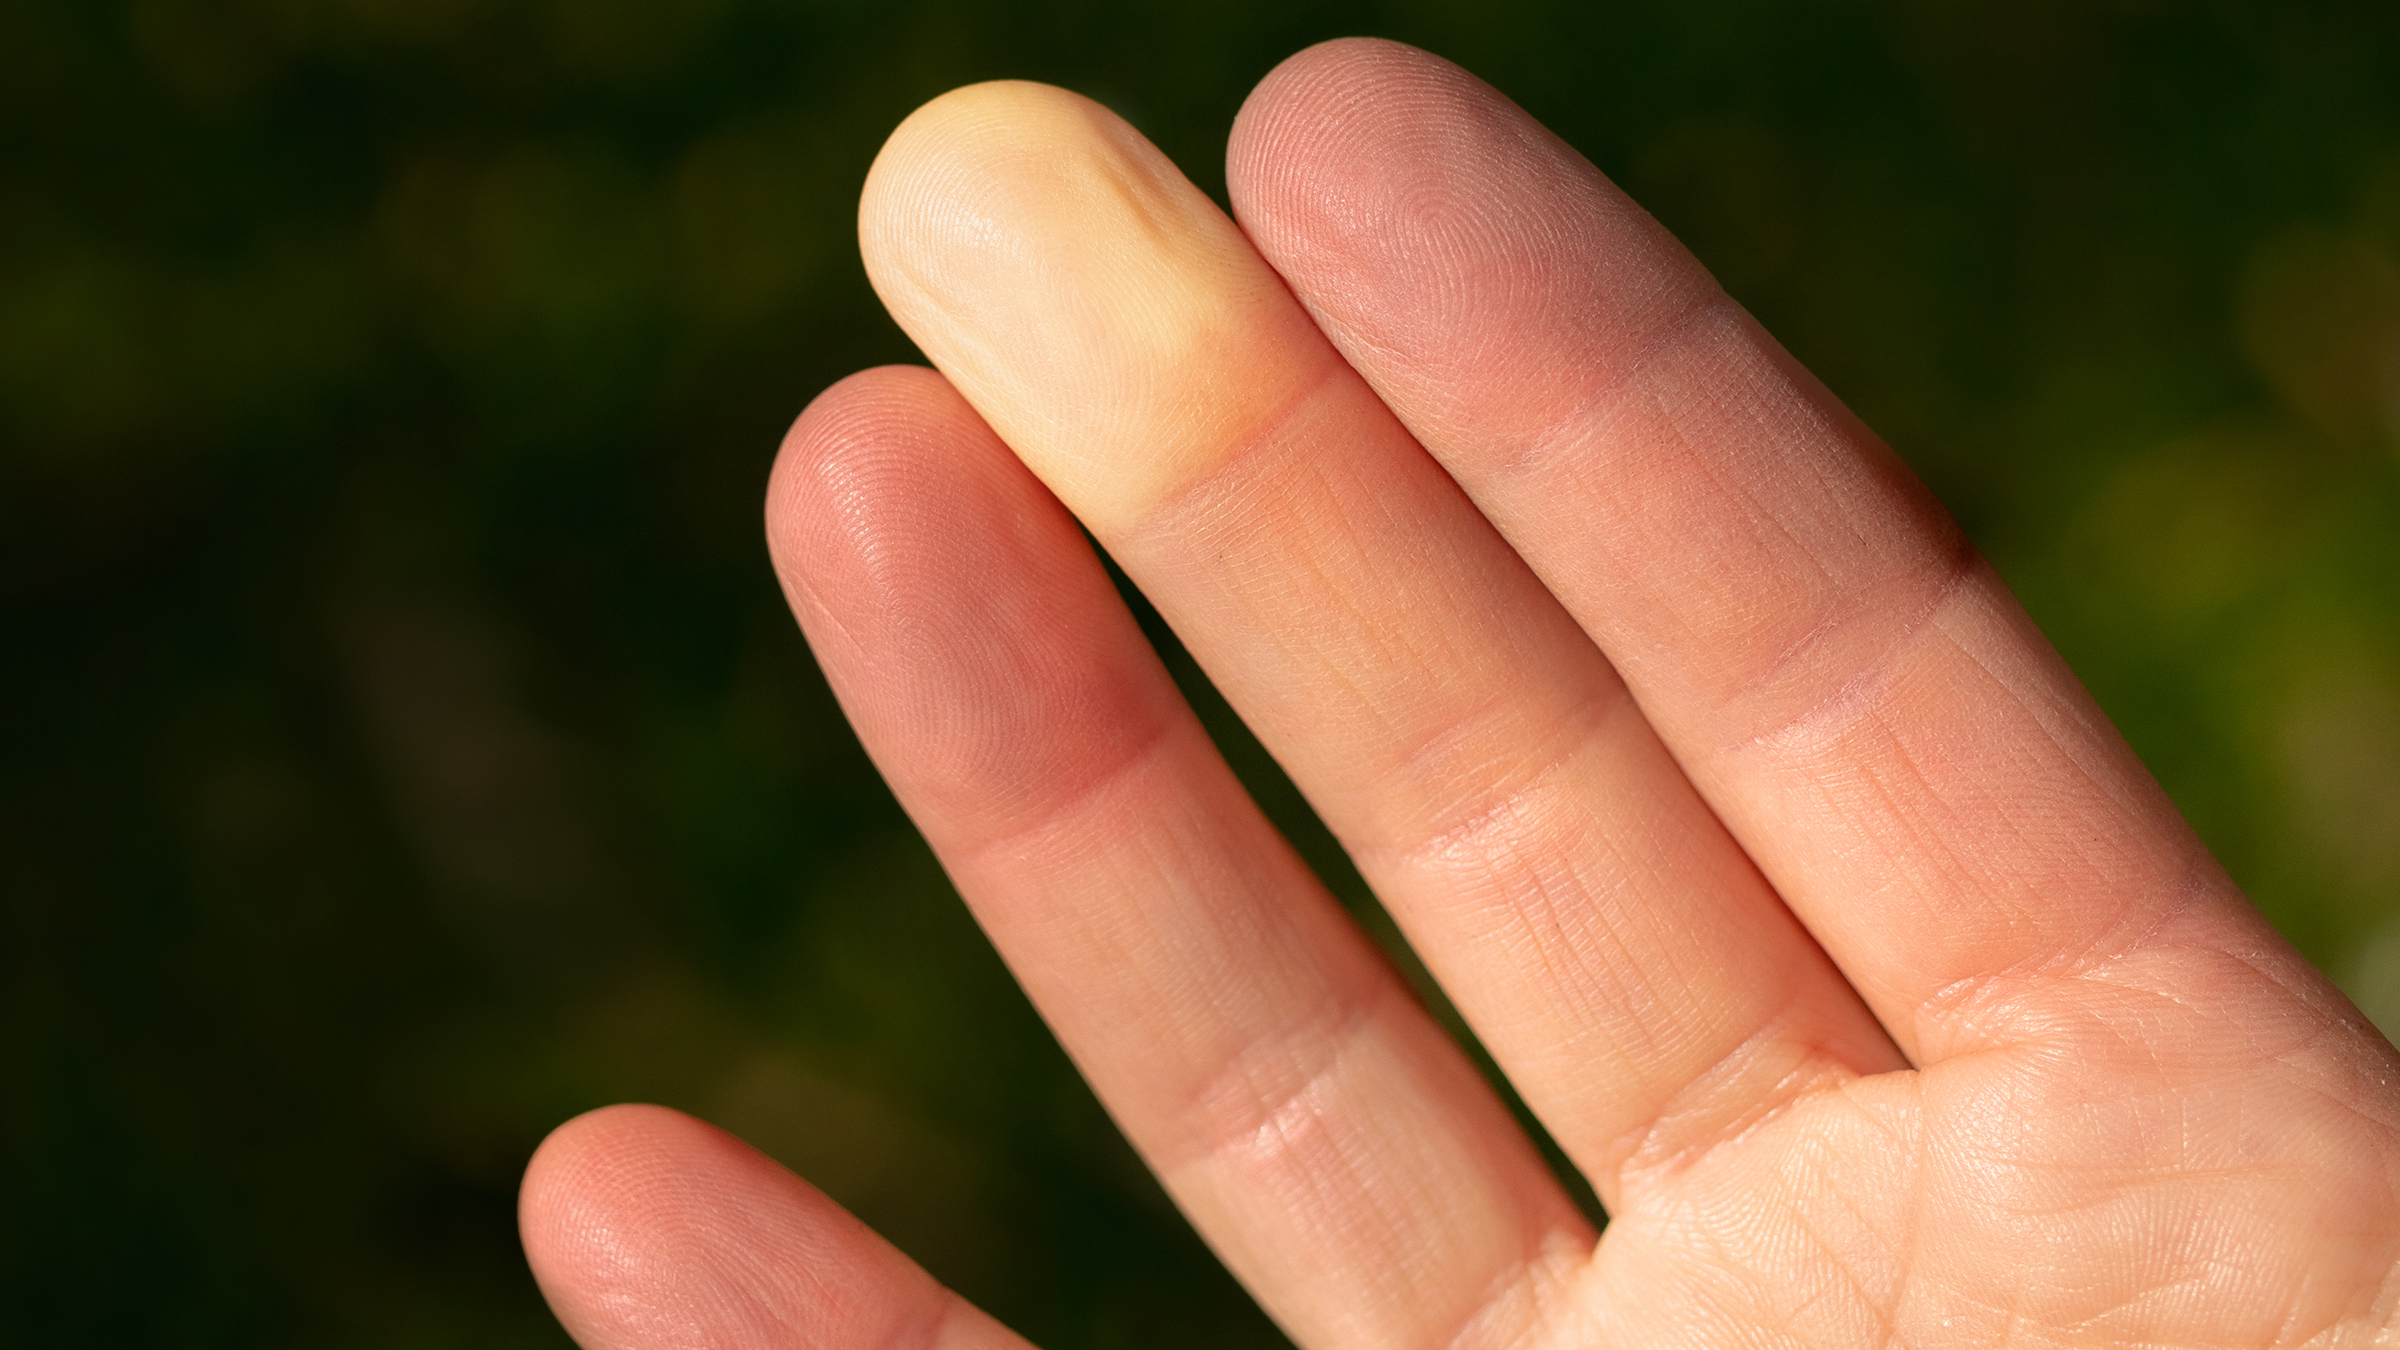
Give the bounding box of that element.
[0,0,2400,1350]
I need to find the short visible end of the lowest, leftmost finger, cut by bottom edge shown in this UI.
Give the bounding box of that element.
[518,1105,1025,1350]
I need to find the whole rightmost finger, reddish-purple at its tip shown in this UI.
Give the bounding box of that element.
[1231,41,2297,1062]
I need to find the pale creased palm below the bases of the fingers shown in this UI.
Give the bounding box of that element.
[1584,1042,2400,1345]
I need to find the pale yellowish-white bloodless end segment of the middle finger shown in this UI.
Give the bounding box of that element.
[859,82,1339,538]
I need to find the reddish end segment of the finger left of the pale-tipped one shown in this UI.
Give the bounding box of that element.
[766,353,1178,841]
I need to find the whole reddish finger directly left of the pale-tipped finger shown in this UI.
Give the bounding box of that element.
[768,370,1591,1350]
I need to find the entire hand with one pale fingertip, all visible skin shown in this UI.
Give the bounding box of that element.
[523,41,2400,1350]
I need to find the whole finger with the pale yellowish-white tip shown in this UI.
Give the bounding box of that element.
[862,84,1901,1201]
